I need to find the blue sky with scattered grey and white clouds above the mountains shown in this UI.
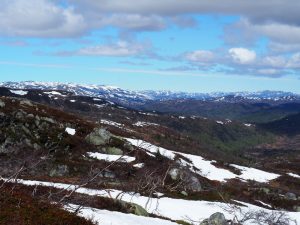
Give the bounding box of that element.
[0,0,300,93]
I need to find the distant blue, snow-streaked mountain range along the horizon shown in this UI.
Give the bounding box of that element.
[0,81,300,105]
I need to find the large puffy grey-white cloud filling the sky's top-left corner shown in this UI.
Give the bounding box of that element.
[0,0,87,37]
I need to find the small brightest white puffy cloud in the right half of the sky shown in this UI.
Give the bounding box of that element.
[228,48,256,64]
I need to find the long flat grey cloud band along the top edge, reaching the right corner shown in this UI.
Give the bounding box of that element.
[69,0,300,24]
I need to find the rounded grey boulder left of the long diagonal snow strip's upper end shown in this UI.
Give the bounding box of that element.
[85,128,112,146]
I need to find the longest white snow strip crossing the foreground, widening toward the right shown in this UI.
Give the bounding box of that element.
[2,180,300,225]
